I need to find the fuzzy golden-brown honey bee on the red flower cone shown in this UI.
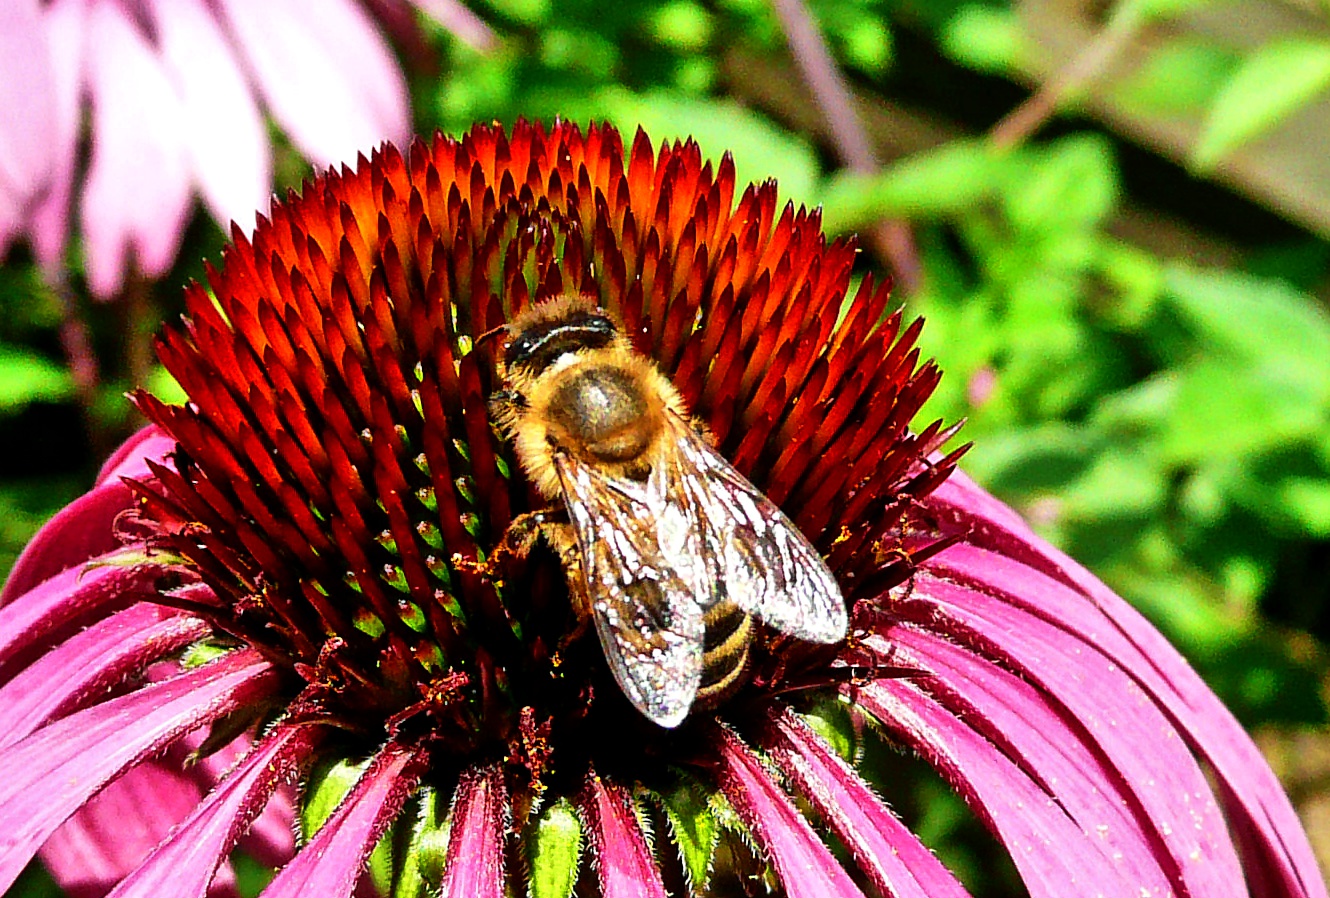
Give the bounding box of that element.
[491,295,847,726]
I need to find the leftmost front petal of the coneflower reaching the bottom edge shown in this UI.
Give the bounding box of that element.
[110,726,319,898]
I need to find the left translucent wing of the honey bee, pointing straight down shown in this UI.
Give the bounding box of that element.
[555,454,706,726]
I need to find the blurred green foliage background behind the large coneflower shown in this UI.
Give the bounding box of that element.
[0,0,1330,894]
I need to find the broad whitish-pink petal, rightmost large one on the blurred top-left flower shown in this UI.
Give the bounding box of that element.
[218,0,411,165]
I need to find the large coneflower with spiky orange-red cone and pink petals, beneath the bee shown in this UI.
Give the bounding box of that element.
[0,124,1326,898]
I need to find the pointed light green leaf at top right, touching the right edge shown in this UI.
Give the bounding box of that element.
[1192,39,1330,170]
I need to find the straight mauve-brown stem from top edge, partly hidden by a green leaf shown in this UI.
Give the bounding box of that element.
[771,0,922,293]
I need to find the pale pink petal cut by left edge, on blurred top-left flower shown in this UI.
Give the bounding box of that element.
[0,0,56,212]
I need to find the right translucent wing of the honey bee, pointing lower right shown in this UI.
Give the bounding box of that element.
[668,414,849,643]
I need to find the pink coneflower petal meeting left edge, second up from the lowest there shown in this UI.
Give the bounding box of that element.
[0,603,210,748]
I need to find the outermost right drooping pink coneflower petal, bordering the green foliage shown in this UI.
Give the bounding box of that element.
[928,476,1326,897]
